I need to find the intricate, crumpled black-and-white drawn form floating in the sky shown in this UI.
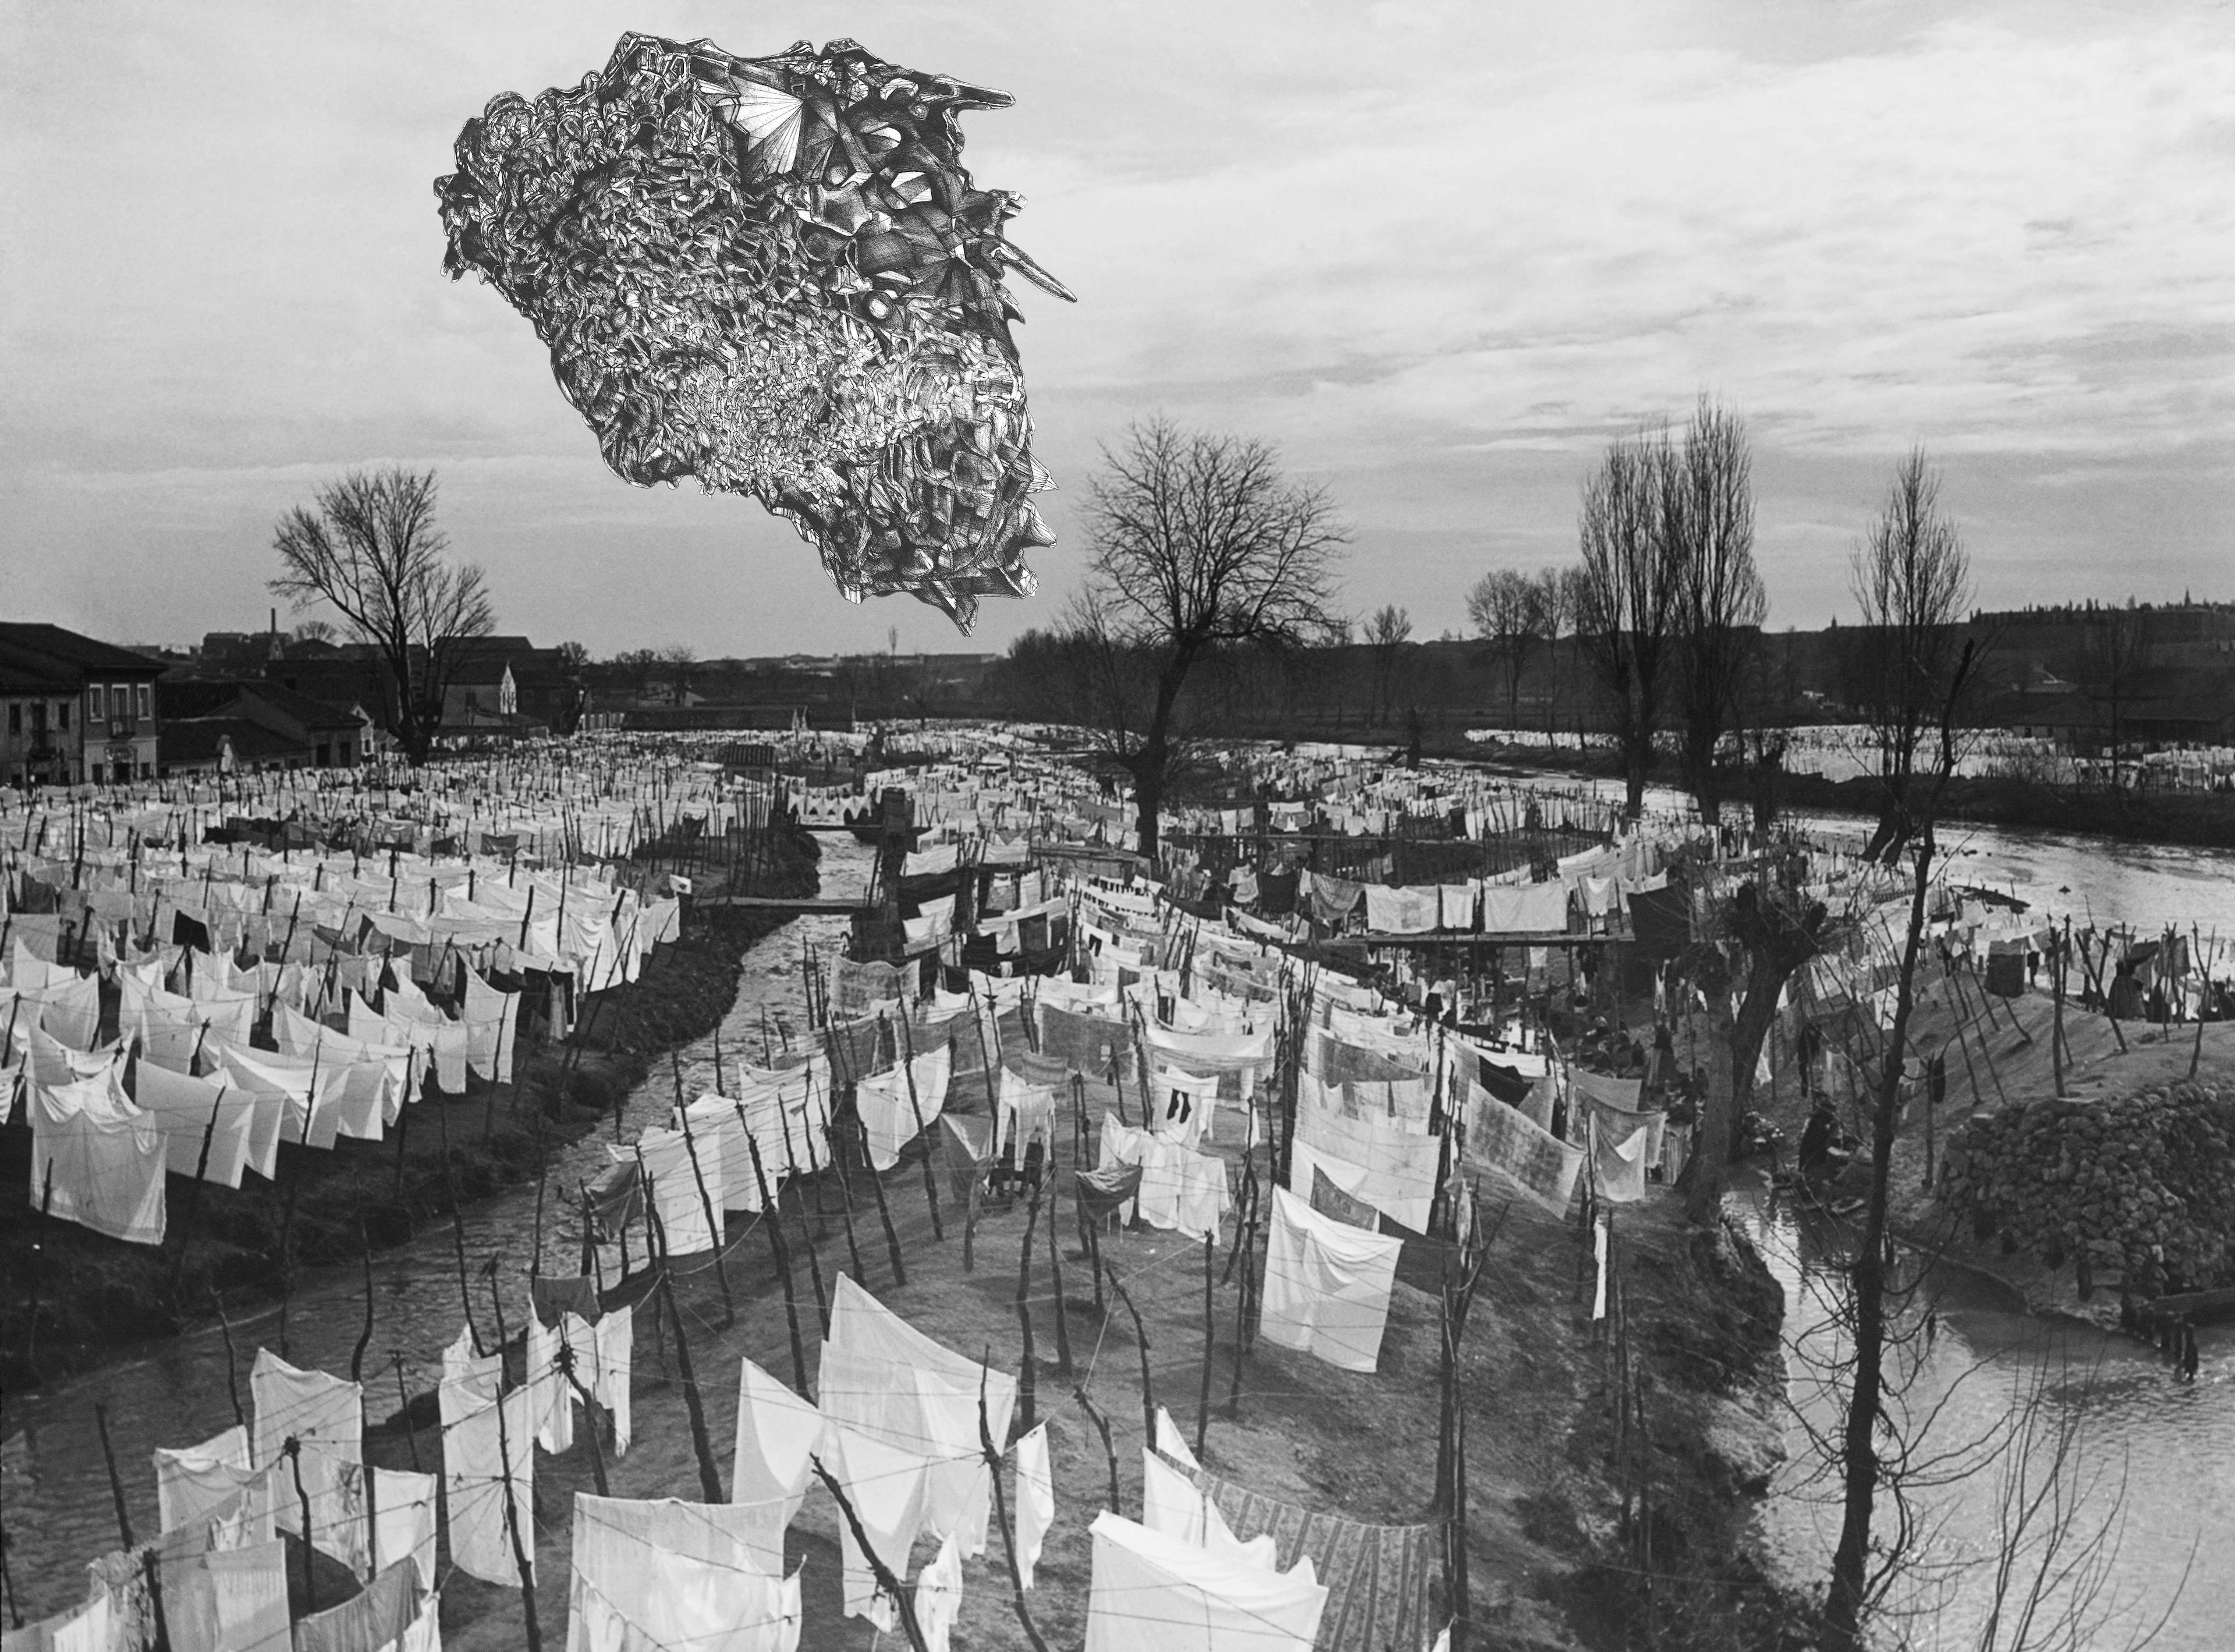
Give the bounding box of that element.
[434,34,1070,630]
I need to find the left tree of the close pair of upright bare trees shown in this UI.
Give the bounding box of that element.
[1576,429,1676,818]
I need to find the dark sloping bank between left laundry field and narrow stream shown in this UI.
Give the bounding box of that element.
[0,827,816,1391]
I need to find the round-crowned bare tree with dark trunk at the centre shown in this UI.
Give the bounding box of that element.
[1077,418,1348,859]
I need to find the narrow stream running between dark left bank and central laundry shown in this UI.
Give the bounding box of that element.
[0,834,874,1621]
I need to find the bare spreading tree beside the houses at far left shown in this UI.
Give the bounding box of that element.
[271,467,496,763]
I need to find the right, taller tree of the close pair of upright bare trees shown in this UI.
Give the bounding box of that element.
[1661,396,1770,825]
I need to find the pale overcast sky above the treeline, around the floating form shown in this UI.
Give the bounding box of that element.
[0,0,2235,655]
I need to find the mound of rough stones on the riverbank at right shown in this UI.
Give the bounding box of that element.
[1940,1082,2235,1295]
